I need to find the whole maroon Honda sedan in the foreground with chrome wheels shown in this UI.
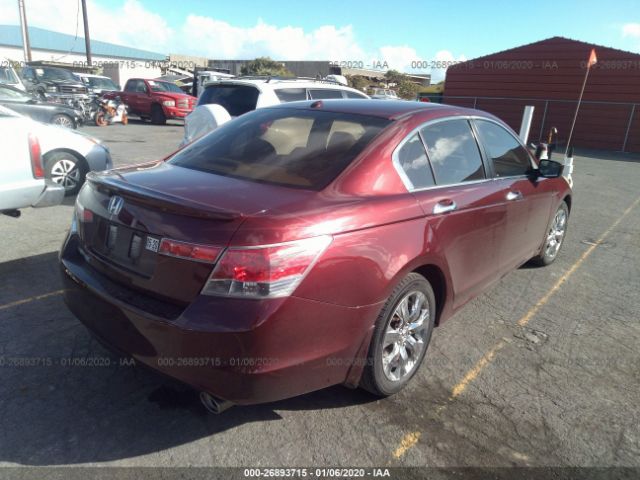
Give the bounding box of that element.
[60,100,571,411]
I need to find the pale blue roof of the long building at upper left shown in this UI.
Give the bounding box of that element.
[0,25,166,60]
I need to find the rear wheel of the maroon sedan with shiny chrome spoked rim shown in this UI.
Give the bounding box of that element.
[360,273,436,397]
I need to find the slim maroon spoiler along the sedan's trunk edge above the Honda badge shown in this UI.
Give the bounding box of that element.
[87,171,243,221]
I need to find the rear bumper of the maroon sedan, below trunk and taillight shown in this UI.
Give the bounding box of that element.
[60,235,380,404]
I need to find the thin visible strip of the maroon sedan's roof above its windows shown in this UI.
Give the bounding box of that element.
[267,98,468,119]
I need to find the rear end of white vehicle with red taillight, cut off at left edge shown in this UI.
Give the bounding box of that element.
[0,110,65,217]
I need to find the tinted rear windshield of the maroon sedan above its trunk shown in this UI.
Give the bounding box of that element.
[169,108,390,190]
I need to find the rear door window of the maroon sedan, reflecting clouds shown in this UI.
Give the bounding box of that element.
[420,119,485,185]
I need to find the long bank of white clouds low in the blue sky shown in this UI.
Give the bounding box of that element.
[0,0,463,79]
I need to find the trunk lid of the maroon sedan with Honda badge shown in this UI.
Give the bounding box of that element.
[78,162,314,305]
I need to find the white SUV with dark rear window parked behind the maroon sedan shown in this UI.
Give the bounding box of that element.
[182,77,369,145]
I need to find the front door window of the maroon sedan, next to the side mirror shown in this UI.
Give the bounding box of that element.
[475,120,531,177]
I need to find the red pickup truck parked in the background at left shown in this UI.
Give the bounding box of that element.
[104,78,197,125]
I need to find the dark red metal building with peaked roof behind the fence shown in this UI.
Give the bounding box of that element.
[443,37,640,152]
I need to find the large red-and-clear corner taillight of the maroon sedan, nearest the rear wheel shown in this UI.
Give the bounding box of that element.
[202,236,332,298]
